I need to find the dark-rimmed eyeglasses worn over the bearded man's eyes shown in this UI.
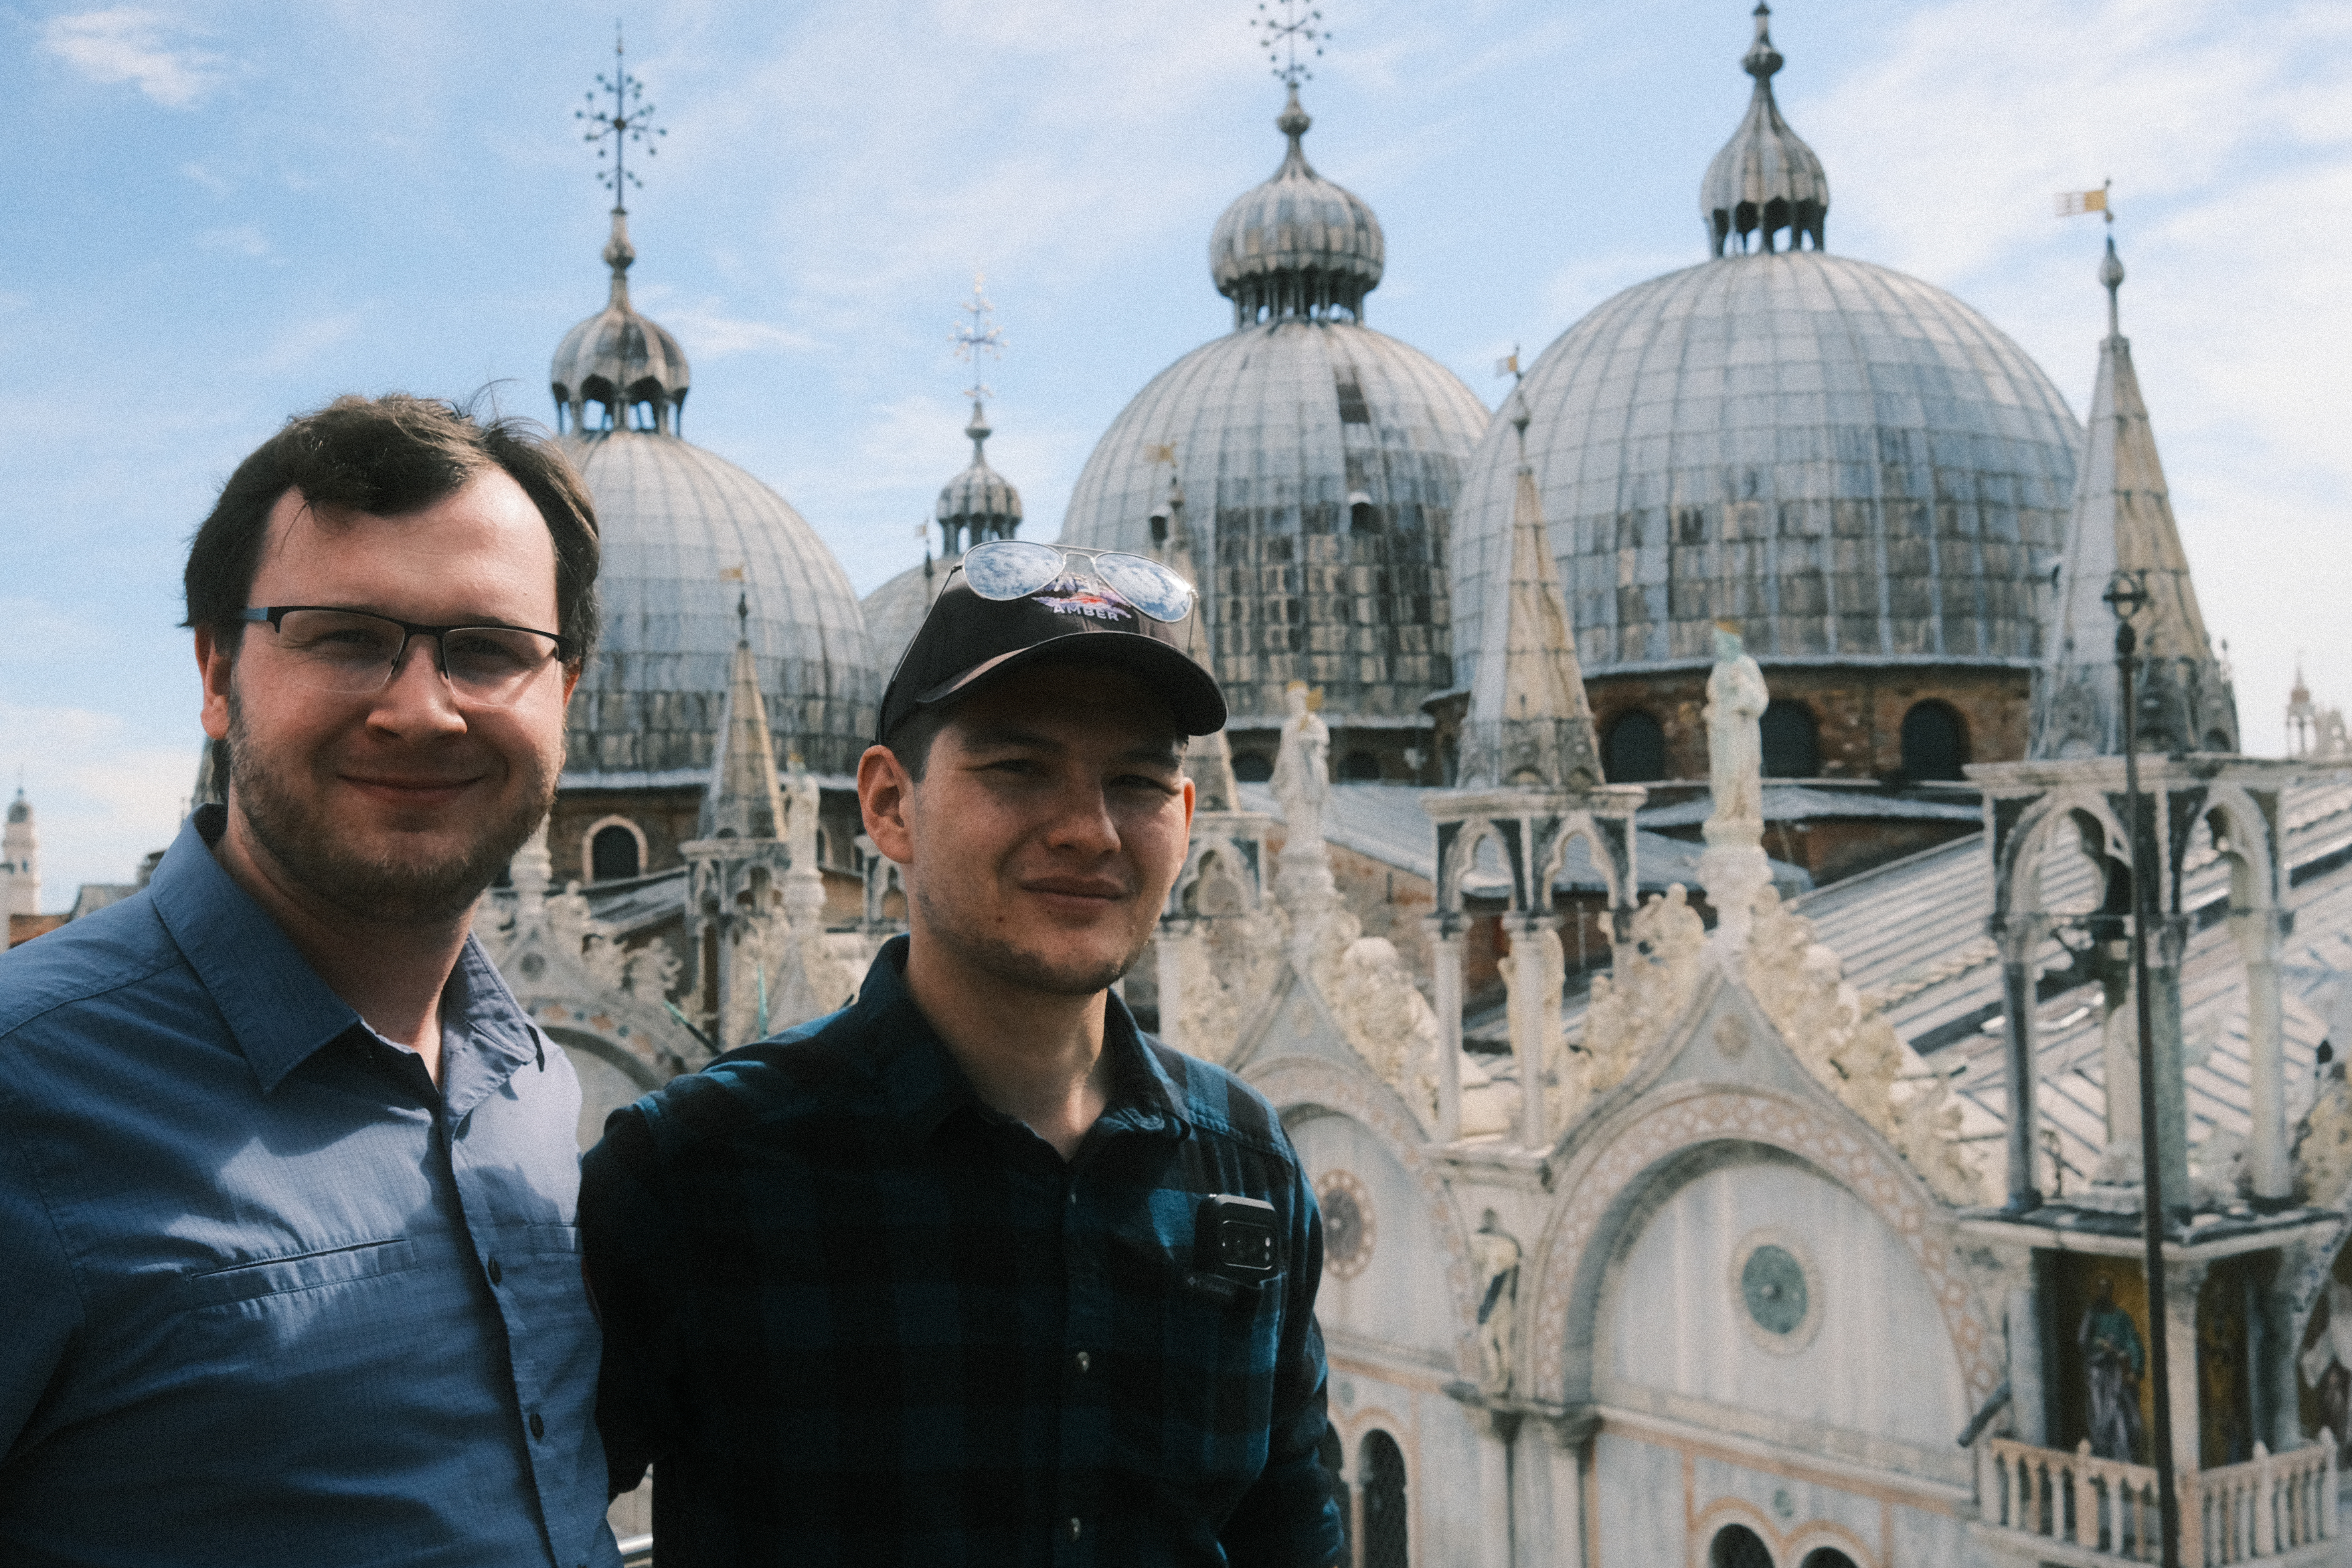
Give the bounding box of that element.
[237,604,571,708]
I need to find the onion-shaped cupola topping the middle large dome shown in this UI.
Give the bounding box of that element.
[1209,85,1386,327]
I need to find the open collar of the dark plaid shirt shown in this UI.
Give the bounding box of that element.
[854,935,1186,1143]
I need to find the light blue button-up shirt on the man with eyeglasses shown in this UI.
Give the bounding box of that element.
[0,806,619,1568]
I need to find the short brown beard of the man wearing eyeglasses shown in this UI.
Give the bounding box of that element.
[228,696,555,926]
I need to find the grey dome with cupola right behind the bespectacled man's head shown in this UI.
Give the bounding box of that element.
[550,214,880,790]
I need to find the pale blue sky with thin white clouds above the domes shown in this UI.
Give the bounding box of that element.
[0,0,2352,908]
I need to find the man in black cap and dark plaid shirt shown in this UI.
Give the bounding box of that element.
[581,541,1341,1568]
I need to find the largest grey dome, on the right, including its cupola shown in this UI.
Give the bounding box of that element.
[1451,7,2081,778]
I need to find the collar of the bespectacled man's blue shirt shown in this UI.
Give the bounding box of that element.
[148,806,546,1117]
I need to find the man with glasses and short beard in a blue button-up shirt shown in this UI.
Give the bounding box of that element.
[0,395,619,1568]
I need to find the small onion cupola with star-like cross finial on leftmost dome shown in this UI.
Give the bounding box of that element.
[548,28,692,435]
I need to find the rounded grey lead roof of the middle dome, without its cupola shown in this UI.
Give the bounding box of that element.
[1061,329,1486,726]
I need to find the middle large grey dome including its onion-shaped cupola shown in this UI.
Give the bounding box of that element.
[1061,92,1486,761]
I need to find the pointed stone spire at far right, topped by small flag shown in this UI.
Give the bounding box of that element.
[2030,233,2239,757]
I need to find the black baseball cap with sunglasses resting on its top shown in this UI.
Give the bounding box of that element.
[875,541,1225,745]
